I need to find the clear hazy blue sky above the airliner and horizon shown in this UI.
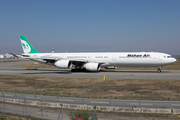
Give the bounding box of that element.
[0,0,180,55]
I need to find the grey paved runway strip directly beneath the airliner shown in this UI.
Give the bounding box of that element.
[0,61,180,80]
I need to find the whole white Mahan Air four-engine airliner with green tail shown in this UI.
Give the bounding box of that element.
[20,36,176,72]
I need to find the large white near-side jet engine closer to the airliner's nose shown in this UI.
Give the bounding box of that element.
[83,63,100,71]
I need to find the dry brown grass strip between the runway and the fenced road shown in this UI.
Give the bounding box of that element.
[0,75,180,100]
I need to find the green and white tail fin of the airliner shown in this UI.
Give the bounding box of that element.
[20,36,39,54]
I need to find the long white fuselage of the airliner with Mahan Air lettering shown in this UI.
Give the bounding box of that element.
[26,52,176,67]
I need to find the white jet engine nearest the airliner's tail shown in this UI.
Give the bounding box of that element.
[54,60,72,69]
